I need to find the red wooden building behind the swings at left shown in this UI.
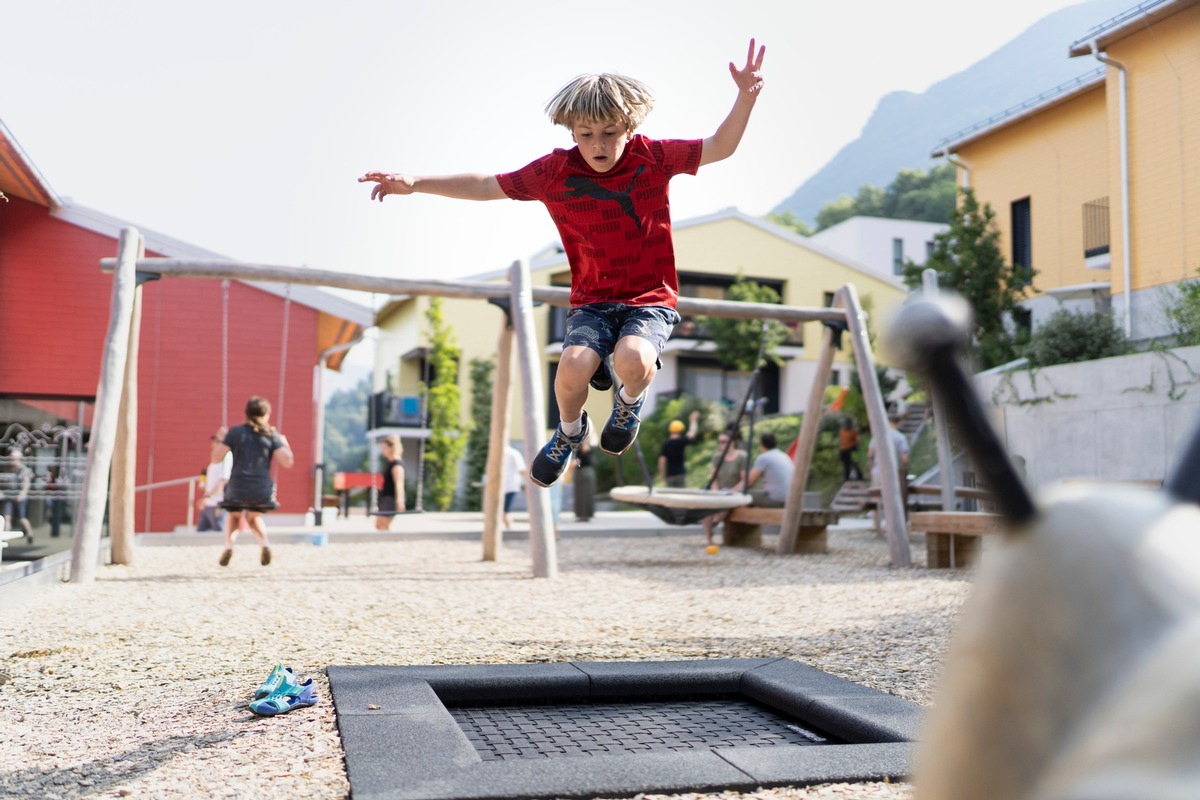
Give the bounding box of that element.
[0,118,373,537]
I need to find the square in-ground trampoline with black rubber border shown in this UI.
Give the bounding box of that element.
[328,658,920,800]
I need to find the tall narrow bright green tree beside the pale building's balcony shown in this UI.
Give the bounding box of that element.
[425,297,467,511]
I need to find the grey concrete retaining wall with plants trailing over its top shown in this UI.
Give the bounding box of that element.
[976,347,1200,489]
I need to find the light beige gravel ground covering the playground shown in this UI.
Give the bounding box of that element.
[0,529,971,800]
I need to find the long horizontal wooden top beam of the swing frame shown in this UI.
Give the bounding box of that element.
[100,258,846,323]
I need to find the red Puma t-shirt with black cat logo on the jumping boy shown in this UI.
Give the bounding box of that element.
[496,134,703,308]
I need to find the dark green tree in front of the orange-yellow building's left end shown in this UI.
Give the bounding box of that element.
[902,188,1034,369]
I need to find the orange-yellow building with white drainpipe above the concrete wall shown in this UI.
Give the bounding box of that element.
[932,0,1200,339]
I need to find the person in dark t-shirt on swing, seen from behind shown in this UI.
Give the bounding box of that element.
[217,396,295,566]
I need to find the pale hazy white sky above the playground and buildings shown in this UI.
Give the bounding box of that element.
[0,0,1102,379]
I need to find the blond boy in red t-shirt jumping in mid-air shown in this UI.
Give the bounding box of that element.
[359,40,767,486]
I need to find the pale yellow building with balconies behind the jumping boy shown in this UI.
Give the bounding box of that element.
[373,209,906,455]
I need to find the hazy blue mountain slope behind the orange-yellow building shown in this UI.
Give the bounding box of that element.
[774,0,1134,222]
